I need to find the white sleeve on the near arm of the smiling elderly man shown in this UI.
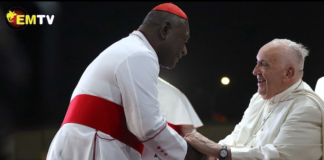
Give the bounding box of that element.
[220,101,322,160]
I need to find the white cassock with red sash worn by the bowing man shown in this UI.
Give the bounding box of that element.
[47,31,187,160]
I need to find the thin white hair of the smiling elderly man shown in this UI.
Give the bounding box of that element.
[271,39,309,71]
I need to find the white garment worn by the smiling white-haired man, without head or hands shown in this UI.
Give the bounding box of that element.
[219,80,324,160]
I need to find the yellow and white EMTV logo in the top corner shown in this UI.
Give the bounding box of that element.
[6,7,55,31]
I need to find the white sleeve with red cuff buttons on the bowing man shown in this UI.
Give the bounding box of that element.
[115,52,187,160]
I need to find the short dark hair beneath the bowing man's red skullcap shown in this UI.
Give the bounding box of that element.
[142,10,186,26]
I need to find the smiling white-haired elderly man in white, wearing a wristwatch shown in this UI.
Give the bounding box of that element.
[185,39,324,160]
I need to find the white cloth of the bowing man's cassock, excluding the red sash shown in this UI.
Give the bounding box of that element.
[47,31,187,160]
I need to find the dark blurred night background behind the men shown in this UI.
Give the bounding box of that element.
[0,1,324,160]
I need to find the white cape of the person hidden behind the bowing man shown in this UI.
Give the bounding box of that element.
[143,77,203,160]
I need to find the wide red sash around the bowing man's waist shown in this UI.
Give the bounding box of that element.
[61,94,144,154]
